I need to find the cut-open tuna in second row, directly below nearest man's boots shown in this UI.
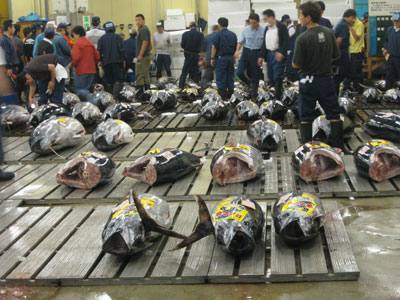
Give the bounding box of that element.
[292,141,344,182]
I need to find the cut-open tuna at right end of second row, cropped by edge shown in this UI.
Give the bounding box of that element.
[354,140,400,182]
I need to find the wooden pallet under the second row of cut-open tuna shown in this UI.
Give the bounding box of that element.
[0,156,400,205]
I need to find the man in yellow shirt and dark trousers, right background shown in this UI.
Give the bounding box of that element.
[349,14,364,94]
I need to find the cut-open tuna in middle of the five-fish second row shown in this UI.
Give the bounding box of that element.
[211,144,265,185]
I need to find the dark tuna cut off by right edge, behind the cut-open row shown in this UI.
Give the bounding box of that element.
[363,112,400,143]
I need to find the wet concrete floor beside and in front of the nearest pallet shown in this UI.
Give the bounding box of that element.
[0,198,400,300]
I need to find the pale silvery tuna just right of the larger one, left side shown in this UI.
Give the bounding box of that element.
[92,119,133,151]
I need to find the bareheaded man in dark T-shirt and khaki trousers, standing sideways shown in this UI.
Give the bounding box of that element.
[136,14,151,99]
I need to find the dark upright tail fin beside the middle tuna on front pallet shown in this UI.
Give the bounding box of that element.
[171,195,215,251]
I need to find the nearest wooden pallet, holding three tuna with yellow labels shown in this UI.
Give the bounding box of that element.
[0,201,360,286]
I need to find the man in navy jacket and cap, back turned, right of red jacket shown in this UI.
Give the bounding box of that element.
[98,22,124,98]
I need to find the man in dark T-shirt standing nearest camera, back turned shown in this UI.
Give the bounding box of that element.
[293,1,344,150]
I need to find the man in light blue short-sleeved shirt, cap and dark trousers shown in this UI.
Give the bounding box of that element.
[235,14,264,99]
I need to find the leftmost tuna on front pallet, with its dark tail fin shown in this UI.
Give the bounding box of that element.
[102,192,187,257]
